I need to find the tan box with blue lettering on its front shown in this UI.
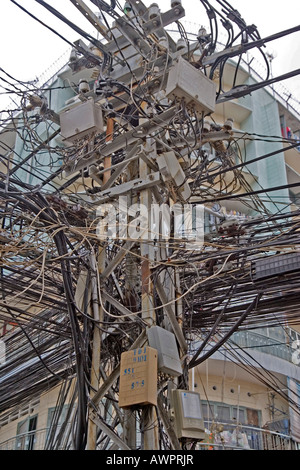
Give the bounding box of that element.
[119,346,157,409]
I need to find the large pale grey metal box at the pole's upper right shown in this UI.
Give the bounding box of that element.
[166,57,216,114]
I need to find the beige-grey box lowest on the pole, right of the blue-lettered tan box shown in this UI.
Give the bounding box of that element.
[170,389,205,441]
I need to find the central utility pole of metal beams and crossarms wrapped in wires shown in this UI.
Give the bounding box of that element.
[55,0,226,450]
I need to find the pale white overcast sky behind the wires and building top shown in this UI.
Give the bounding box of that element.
[0,0,300,109]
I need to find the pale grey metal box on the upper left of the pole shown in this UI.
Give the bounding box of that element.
[60,99,104,142]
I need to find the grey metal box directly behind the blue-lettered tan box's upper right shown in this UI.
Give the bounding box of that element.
[147,326,182,377]
